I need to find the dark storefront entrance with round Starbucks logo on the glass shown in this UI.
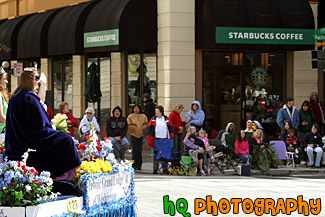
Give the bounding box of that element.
[203,52,285,138]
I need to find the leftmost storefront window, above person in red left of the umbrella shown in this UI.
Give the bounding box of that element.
[52,57,73,113]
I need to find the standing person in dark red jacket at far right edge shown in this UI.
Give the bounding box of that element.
[310,92,325,135]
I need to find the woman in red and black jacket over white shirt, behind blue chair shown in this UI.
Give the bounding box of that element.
[146,105,174,174]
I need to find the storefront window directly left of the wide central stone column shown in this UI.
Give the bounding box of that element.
[127,53,157,114]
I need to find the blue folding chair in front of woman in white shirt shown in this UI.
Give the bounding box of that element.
[155,139,180,175]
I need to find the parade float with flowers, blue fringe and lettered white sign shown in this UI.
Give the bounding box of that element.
[0,114,137,217]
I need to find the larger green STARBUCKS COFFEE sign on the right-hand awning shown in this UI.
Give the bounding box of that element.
[216,27,315,45]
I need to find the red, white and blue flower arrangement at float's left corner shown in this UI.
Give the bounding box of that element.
[0,149,59,206]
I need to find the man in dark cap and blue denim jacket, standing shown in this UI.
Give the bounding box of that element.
[276,97,299,130]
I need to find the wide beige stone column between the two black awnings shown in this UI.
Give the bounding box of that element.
[157,0,195,118]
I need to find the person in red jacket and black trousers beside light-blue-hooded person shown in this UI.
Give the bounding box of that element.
[168,104,188,156]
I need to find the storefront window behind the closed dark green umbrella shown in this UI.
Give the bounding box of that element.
[86,53,111,123]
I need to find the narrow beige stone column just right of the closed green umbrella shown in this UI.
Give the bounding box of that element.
[111,53,125,109]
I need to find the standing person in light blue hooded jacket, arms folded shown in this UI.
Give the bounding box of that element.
[186,101,205,132]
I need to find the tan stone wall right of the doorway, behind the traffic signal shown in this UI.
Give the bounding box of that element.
[293,4,319,109]
